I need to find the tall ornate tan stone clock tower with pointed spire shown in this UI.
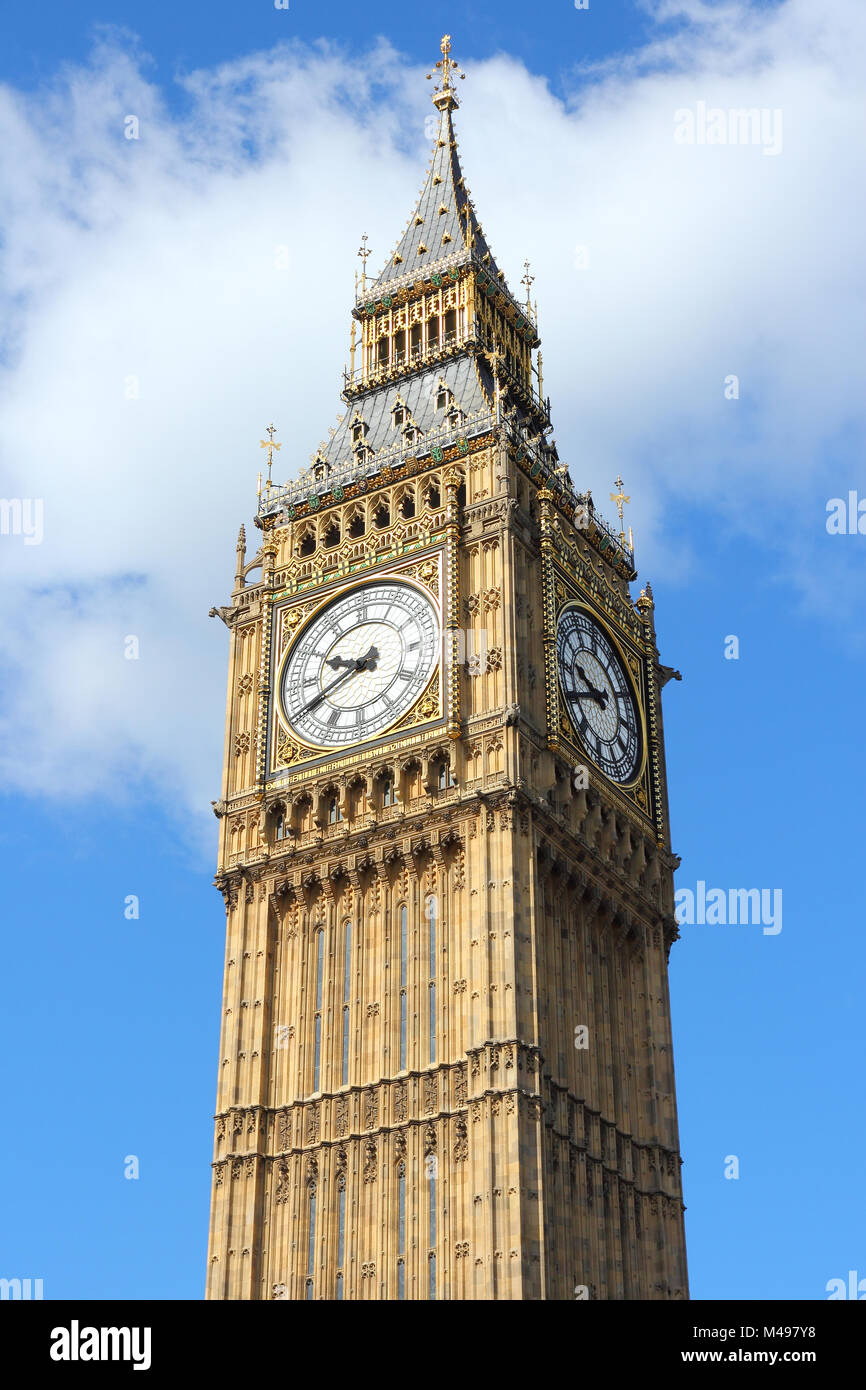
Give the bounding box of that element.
[207,38,688,1300]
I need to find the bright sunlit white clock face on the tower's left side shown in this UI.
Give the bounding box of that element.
[281,580,439,748]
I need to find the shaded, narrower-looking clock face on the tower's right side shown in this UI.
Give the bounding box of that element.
[556,606,642,784]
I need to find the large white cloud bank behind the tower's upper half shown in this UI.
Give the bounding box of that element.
[0,0,866,809]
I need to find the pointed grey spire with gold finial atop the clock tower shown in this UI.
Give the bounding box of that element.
[366,33,507,299]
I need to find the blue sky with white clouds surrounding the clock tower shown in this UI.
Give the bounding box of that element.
[0,0,866,1298]
